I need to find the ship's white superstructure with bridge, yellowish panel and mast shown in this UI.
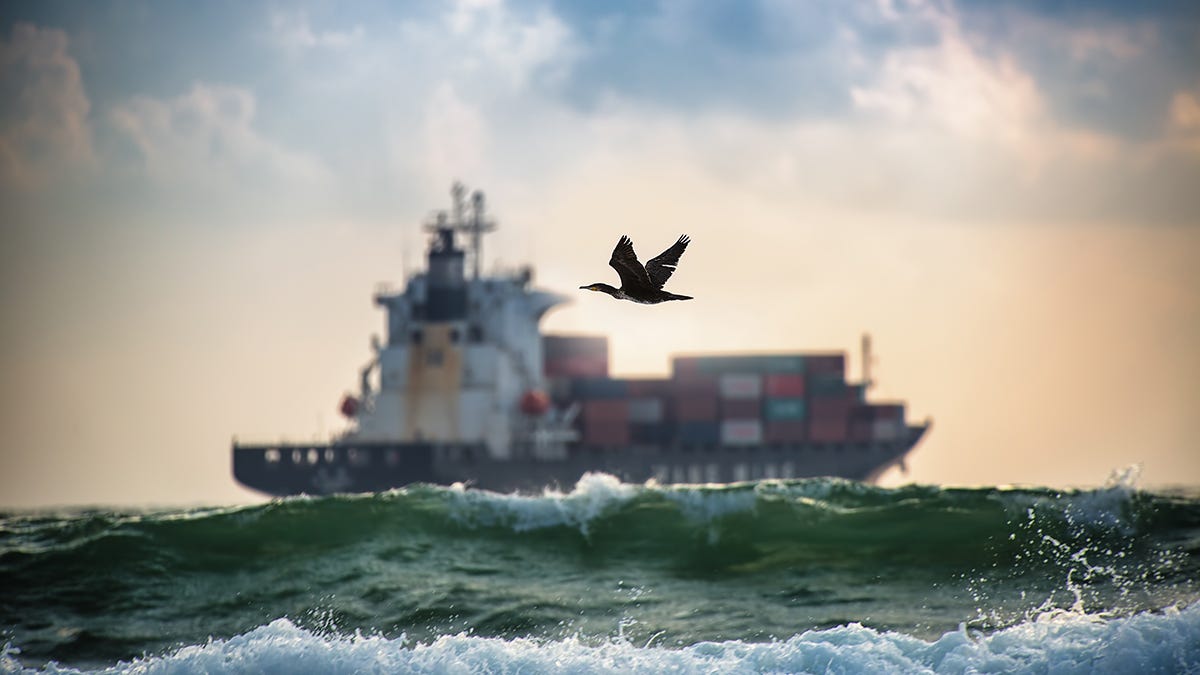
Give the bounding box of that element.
[346,184,566,459]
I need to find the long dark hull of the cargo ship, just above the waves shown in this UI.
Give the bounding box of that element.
[233,425,926,496]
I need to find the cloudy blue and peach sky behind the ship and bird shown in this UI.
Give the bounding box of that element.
[0,0,1200,508]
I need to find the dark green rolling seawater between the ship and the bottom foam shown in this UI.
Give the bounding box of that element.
[0,476,1200,668]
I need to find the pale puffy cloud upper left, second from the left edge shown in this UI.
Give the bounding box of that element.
[109,83,328,187]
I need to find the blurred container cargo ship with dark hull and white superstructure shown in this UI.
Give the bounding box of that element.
[233,184,930,496]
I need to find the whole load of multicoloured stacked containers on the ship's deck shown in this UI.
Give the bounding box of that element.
[546,336,906,447]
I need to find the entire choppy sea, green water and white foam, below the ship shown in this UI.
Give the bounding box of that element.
[0,474,1200,674]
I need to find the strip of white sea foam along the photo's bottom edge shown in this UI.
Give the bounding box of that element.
[11,603,1200,675]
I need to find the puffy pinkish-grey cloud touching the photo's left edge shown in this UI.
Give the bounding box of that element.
[0,24,94,189]
